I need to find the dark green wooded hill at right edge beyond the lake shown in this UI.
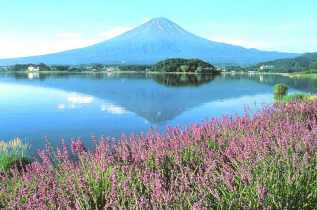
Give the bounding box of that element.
[255,52,317,72]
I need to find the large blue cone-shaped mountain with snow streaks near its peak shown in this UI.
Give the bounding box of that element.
[0,18,299,65]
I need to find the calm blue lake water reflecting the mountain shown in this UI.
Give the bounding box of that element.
[0,73,317,151]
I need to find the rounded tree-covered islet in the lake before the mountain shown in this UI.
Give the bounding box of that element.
[151,58,220,74]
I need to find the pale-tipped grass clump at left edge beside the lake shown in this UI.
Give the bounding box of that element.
[0,138,30,170]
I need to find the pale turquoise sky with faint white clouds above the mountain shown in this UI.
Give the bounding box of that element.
[0,0,317,58]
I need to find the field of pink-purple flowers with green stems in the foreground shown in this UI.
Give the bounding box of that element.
[0,100,317,209]
